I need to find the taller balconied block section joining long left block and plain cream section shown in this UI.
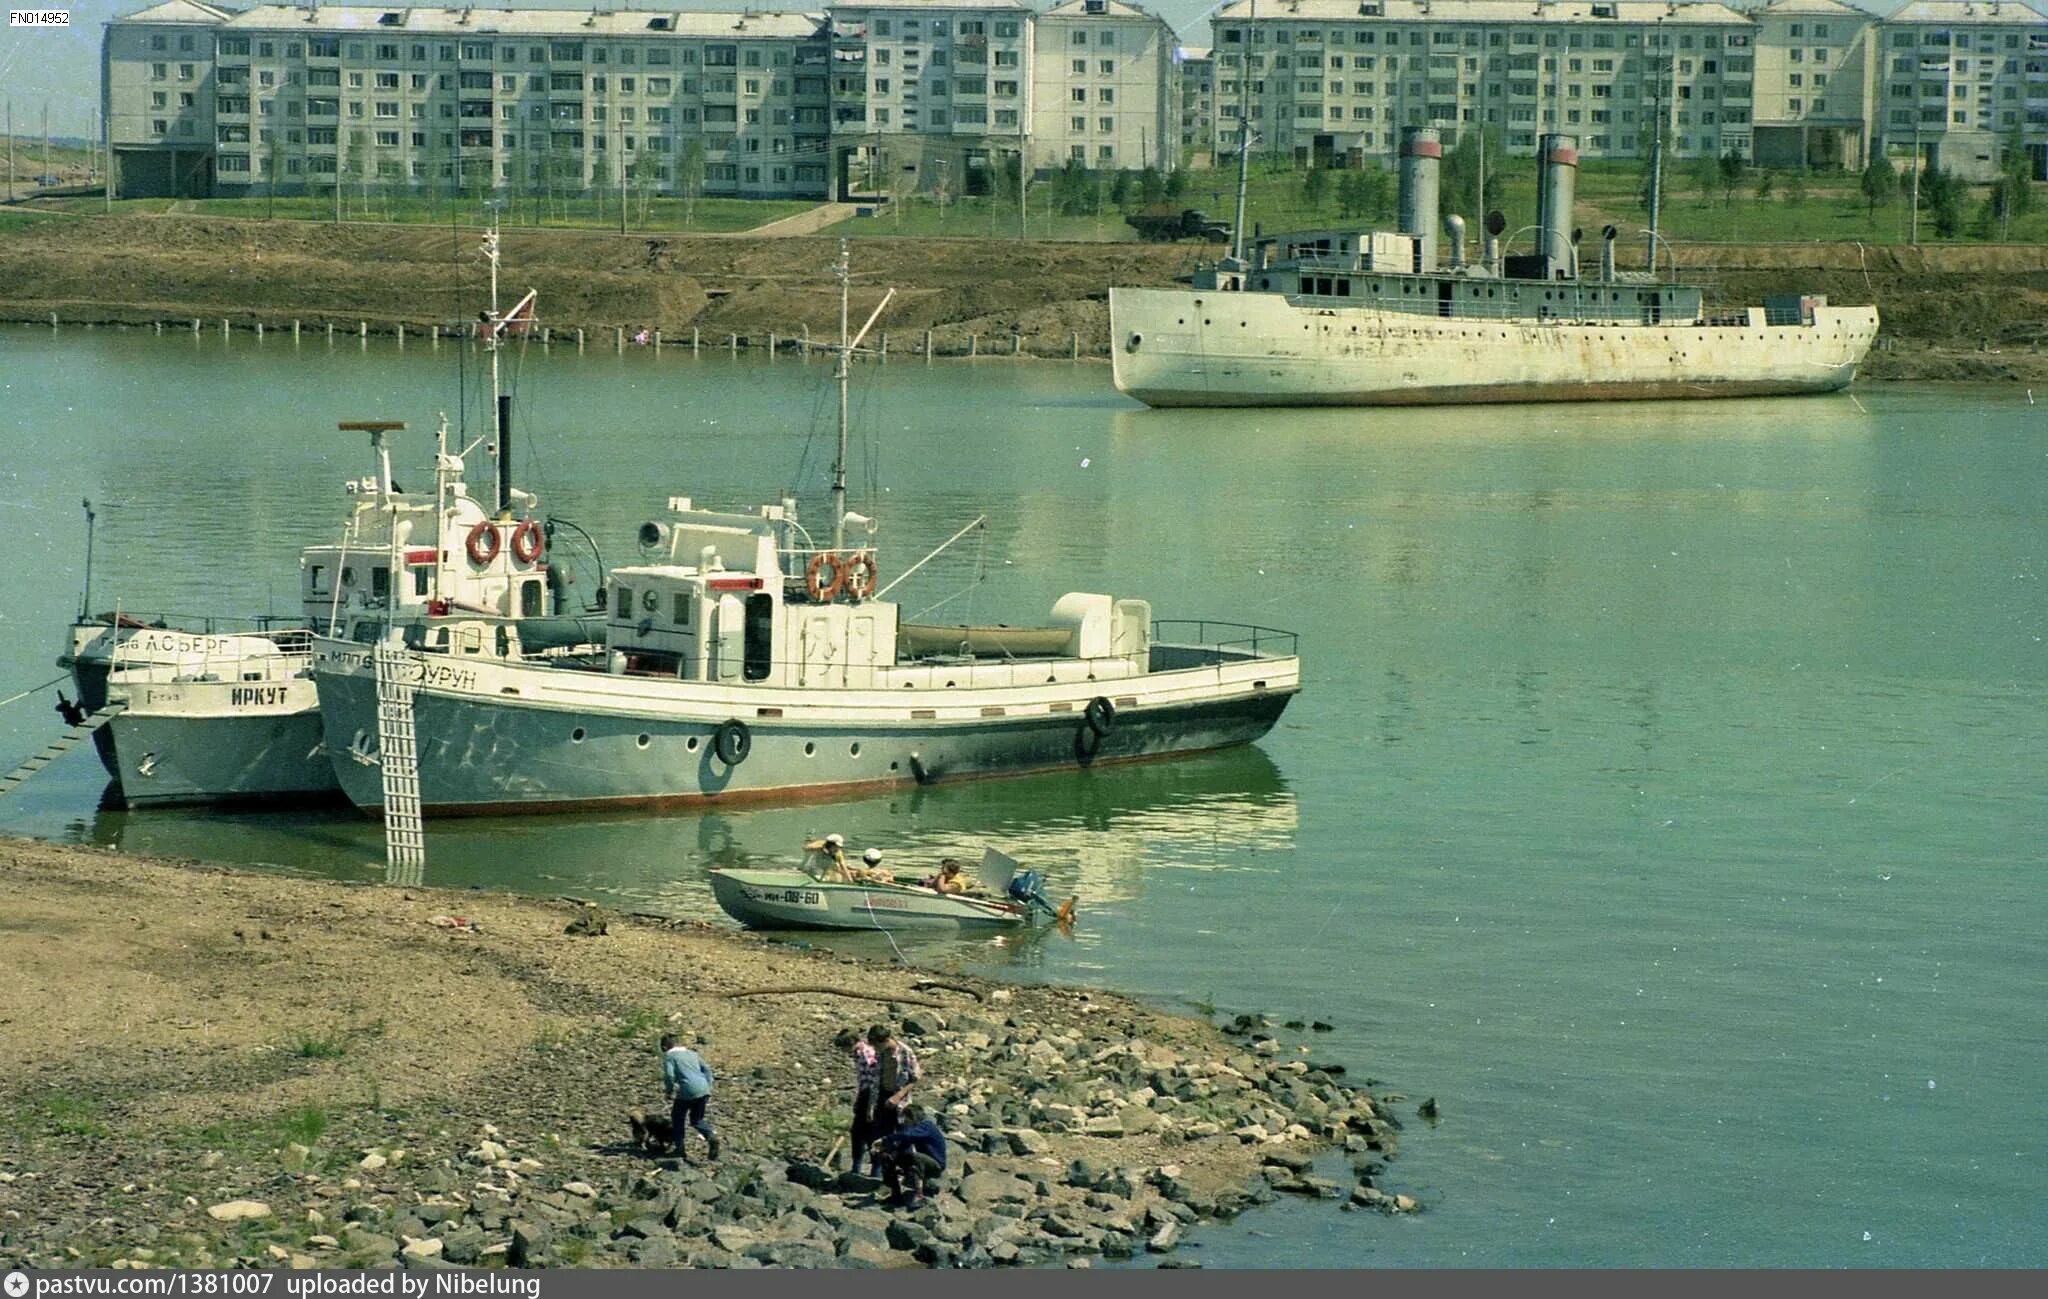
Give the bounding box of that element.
[831,0,1032,195]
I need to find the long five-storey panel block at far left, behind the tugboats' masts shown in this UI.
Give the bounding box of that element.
[106,0,829,197]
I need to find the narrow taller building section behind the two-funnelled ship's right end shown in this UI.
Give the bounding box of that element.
[1749,0,1878,168]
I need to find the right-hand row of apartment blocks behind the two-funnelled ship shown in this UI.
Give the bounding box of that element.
[1210,0,2048,178]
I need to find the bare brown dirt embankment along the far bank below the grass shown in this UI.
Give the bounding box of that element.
[0,217,2048,381]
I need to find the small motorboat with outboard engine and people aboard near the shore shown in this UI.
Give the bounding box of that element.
[711,848,1073,930]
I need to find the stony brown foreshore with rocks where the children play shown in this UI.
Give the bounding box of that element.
[0,840,1434,1268]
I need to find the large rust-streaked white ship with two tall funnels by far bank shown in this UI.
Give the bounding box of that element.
[1110,127,1878,406]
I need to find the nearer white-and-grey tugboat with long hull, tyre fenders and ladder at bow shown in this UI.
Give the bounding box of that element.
[313,247,1300,815]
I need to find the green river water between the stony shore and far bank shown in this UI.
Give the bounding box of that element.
[0,328,2048,1266]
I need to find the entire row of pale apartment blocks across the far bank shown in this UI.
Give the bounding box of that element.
[102,0,2048,199]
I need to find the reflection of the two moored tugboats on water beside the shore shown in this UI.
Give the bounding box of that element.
[82,748,1300,963]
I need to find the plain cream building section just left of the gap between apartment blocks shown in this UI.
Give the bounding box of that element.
[1030,0,1180,170]
